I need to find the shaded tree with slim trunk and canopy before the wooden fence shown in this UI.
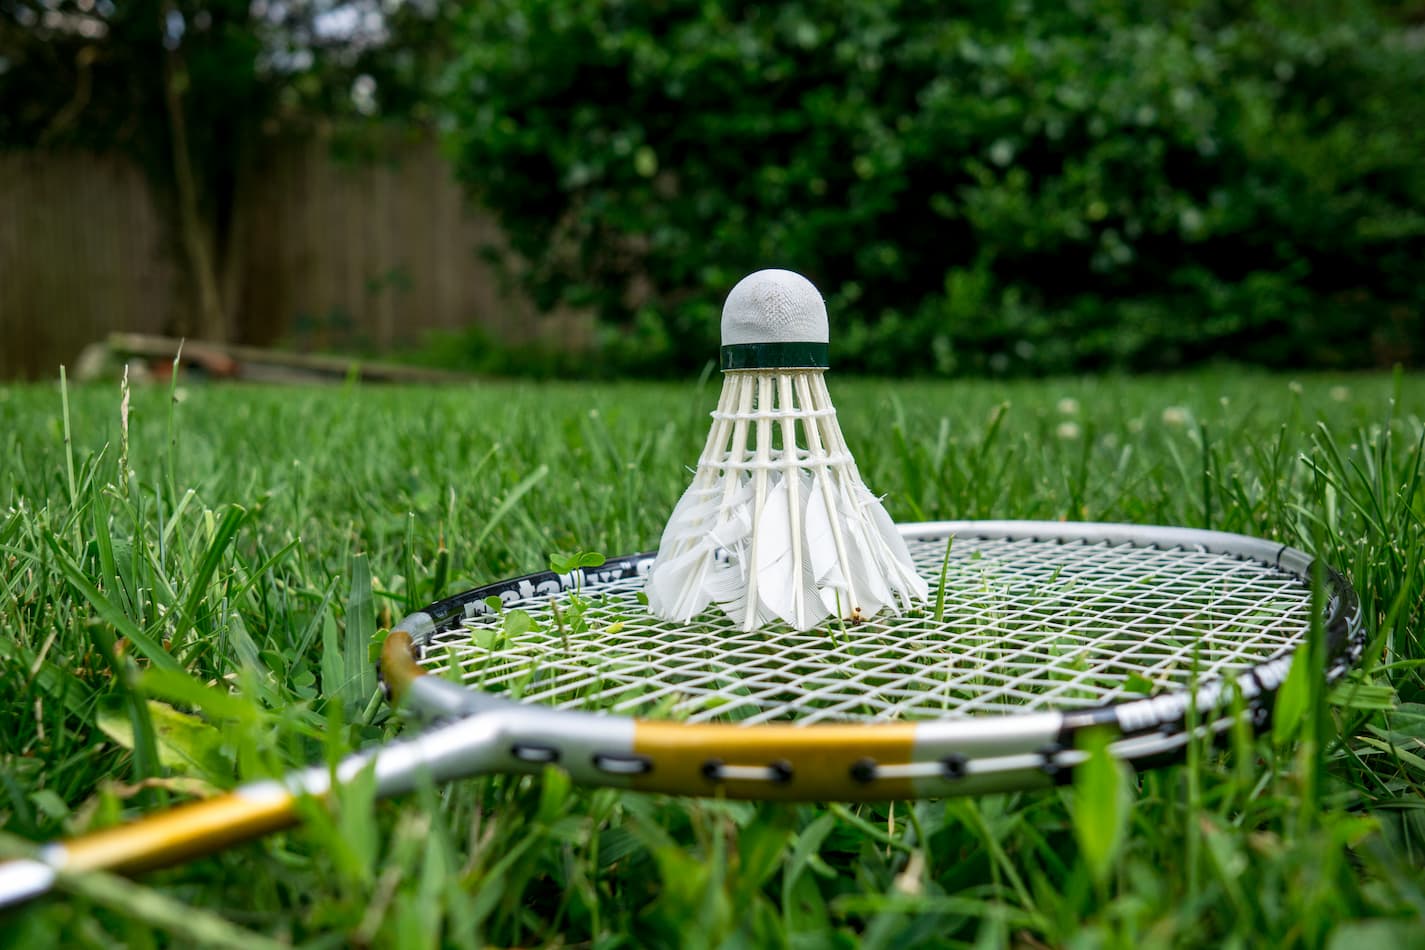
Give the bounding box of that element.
[0,0,443,339]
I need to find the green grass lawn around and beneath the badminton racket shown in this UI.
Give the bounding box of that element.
[0,373,1425,947]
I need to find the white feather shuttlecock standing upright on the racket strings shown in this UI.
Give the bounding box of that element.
[647,271,928,630]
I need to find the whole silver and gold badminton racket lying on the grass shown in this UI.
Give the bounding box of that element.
[0,521,1365,904]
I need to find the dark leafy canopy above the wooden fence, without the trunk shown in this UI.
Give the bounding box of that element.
[0,0,442,149]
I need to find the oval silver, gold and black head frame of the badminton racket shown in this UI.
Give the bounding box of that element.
[380,521,1365,800]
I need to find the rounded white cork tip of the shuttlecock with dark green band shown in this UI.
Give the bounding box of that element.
[722,271,828,370]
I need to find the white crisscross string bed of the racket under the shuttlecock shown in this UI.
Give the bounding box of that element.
[423,538,1311,724]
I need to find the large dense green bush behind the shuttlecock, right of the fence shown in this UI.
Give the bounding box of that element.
[443,0,1425,372]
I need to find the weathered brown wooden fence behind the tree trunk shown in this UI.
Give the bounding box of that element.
[0,140,590,379]
